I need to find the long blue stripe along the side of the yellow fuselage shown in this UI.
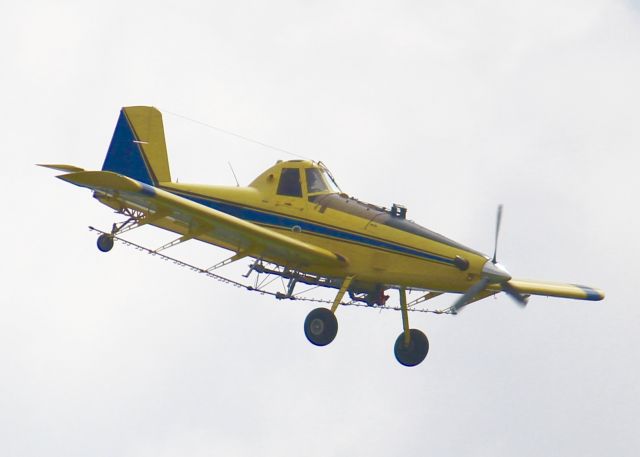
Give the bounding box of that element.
[165,189,453,265]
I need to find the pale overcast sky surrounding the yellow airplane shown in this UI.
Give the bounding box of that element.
[0,0,640,457]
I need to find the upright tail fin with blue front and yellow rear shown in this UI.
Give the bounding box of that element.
[102,106,171,185]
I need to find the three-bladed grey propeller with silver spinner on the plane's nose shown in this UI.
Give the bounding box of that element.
[450,205,529,314]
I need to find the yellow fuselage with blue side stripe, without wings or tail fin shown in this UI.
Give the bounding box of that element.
[109,161,487,292]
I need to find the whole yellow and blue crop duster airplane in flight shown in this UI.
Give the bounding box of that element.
[43,106,604,366]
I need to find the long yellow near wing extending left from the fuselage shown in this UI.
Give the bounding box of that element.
[57,167,347,267]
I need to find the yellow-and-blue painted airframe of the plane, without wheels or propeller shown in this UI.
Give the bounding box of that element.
[41,106,604,300]
